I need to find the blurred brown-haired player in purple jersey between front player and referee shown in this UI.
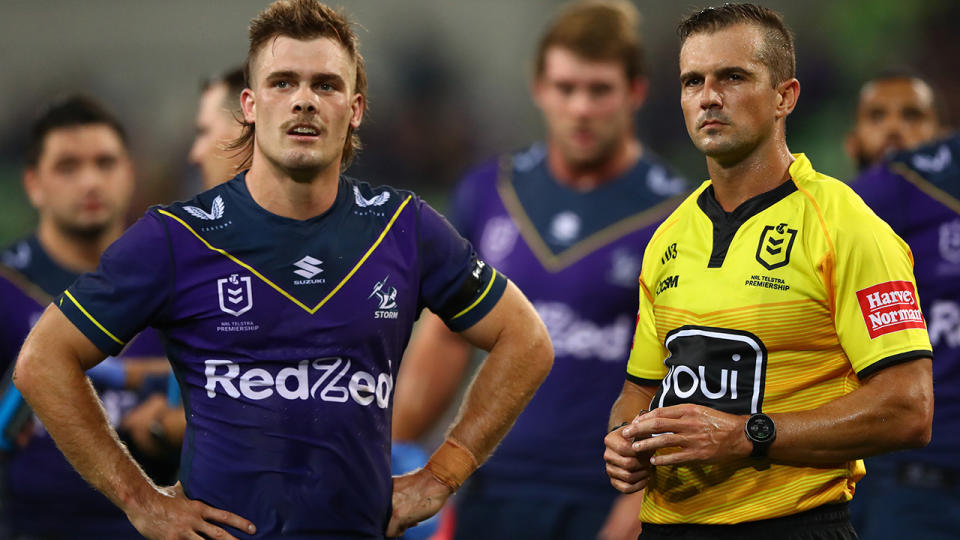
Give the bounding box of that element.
[394,1,685,539]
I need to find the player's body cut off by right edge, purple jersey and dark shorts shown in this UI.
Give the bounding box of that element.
[851,135,960,540]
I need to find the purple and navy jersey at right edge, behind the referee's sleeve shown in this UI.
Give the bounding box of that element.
[853,134,960,468]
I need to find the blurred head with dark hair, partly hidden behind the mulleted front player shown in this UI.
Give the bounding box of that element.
[189,67,247,190]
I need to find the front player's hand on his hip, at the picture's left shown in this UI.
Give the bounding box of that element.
[127,482,257,540]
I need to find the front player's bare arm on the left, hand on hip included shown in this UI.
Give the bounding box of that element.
[13,306,254,538]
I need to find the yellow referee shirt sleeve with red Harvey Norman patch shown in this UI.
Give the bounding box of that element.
[833,200,933,378]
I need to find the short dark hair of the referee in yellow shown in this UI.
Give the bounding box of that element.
[677,4,797,86]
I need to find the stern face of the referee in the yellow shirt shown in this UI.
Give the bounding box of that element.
[680,24,780,163]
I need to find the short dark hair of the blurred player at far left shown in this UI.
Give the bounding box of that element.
[24,94,128,167]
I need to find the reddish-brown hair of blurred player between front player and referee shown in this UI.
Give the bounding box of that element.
[534,0,646,81]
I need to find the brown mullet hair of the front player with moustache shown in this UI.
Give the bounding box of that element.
[227,0,367,171]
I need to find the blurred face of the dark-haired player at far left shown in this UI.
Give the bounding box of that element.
[24,124,133,237]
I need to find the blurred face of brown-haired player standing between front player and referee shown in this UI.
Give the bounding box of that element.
[533,47,646,167]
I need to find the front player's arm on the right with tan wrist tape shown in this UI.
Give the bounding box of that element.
[387,283,553,536]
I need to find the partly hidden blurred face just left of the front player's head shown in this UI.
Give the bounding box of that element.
[190,83,242,189]
